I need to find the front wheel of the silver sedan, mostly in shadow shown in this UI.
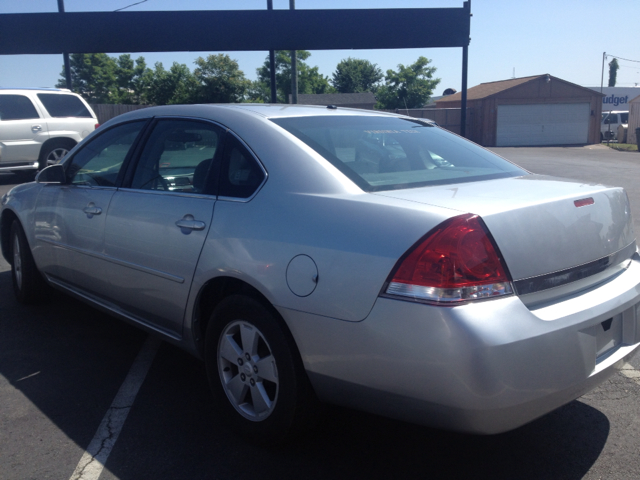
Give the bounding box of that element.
[9,220,51,305]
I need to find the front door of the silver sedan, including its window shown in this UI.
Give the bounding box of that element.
[34,120,147,292]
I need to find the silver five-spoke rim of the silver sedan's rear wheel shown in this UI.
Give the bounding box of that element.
[218,320,279,422]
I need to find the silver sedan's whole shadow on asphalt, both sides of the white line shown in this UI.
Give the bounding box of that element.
[0,272,610,480]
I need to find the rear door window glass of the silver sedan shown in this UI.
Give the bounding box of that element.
[131,119,222,194]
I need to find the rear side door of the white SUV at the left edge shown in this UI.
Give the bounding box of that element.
[0,94,49,163]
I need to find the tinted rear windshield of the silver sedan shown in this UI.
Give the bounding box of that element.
[271,116,527,192]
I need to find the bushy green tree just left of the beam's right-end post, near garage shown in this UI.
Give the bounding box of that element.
[376,57,440,110]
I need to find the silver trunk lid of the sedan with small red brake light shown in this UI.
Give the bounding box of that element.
[376,175,635,288]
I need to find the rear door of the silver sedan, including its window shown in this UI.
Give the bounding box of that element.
[105,118,224,338]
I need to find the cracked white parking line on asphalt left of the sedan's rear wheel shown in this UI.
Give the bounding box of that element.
[70,336,162,480]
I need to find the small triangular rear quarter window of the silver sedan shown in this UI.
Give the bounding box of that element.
[219,135,265,198]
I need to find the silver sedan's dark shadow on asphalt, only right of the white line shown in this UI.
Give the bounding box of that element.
[105,344,610,480]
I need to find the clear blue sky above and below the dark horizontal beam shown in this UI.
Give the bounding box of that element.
[0,0,640,95]
